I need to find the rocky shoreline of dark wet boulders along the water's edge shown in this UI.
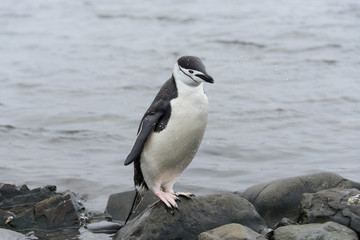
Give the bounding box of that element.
[0,172,360,240]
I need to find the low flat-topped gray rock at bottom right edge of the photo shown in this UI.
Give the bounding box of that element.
[272,222,358,240]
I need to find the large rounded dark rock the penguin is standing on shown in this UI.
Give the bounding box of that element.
[114,193,267,240]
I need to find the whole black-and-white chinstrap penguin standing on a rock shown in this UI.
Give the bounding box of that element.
[124,56,214,223]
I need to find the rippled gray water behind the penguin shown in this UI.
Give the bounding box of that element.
[0,0,360,239]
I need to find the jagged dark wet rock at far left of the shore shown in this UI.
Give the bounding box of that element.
[0,184,80,231]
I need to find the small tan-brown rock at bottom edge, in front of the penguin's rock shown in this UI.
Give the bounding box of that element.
[195,223,266,240]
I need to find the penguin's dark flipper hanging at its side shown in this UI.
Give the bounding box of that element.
[124,111,163,166]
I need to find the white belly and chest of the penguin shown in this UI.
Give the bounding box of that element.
[140,92,208,189]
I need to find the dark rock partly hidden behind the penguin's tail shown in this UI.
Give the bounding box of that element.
[105,191,158,221]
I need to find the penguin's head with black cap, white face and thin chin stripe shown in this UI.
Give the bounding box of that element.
[173,56,214,87]
